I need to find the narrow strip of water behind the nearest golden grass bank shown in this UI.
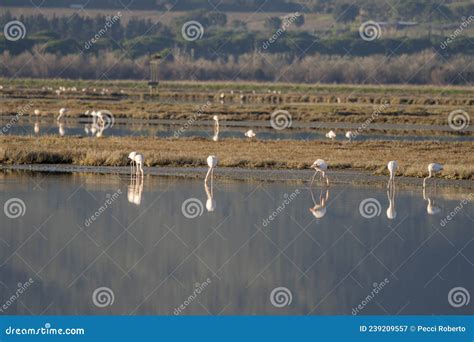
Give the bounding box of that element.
[0,121,474,141]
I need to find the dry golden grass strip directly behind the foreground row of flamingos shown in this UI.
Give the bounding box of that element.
[0,136,474,179]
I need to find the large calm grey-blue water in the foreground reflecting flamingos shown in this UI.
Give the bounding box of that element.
[0,173,474,315]
